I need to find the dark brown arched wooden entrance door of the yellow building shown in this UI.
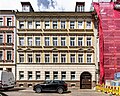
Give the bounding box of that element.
[80,72,91,89]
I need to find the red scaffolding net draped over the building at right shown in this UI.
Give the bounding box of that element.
[93,0,120,84]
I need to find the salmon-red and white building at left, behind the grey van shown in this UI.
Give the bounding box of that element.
[0,10,16,75]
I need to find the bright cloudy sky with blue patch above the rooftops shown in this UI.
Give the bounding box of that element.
[0,0,101,11]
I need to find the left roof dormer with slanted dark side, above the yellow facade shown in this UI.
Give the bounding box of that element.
[21,2,34,12]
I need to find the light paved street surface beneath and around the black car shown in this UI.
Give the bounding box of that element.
[0,88,110,96]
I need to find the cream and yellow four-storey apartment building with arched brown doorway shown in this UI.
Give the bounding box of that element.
[16,2,97,89]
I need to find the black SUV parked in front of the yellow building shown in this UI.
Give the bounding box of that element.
[33,80,68,94]
